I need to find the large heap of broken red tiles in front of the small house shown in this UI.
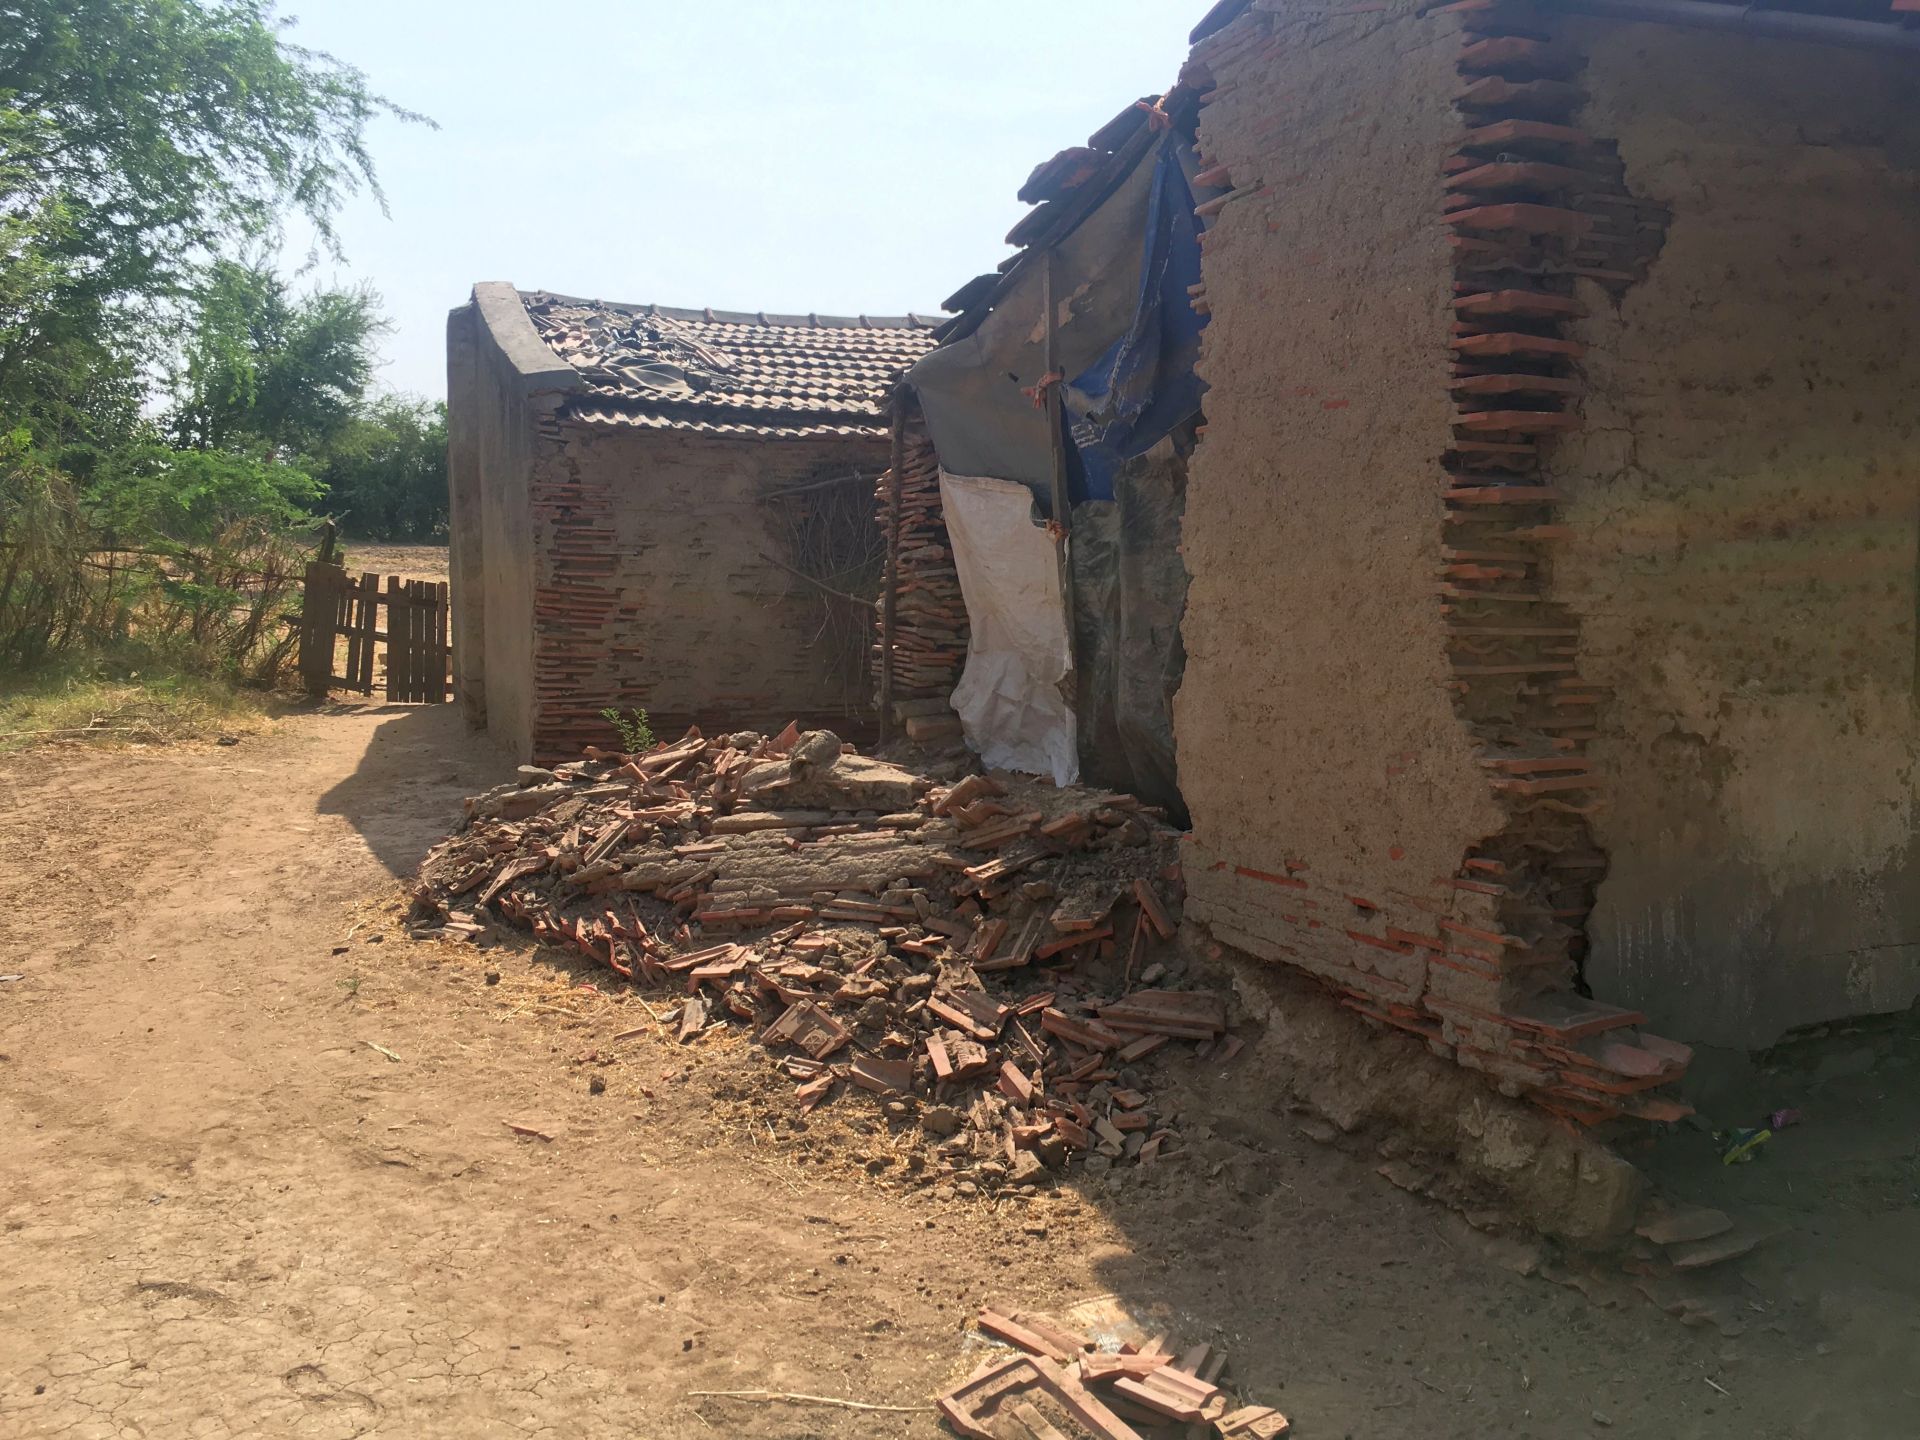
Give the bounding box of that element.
[415,726,1240,1192]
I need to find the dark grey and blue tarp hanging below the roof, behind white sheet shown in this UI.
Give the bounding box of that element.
[908,132,1198,820]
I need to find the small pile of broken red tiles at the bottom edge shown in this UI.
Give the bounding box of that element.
[937,1309,1286,1440]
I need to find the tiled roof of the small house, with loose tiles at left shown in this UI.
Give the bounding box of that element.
[520,292,933,438]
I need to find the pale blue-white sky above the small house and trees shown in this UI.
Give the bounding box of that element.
[284,0,1208,397]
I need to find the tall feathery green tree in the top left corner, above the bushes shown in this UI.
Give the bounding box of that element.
[0,0,419,444]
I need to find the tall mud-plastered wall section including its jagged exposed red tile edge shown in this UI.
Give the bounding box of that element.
[1177,2,1686,1123]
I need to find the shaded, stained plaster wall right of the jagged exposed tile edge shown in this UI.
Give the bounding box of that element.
[1549,23,1920,1046]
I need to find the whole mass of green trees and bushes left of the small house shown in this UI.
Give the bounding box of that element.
[0,0,444,683]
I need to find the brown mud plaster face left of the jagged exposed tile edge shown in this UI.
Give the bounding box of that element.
[1175,4,1501,1000]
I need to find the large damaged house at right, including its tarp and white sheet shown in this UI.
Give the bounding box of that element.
[879,0,1920,1123]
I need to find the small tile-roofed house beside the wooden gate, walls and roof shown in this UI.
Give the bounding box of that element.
[447,284,929,760]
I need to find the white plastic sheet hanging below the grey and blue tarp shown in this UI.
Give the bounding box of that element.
[941,470,1079,785]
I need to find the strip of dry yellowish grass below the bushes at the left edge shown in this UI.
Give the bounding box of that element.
[0,670,275,755]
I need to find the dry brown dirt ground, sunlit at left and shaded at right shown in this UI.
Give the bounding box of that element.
[0,705,1920,1440]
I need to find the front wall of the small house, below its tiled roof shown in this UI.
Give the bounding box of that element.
[532,422,889,755]
